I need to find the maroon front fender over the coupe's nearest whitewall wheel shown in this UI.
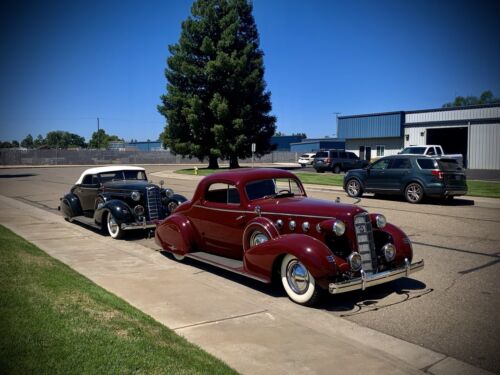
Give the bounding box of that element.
[244,234,337,281]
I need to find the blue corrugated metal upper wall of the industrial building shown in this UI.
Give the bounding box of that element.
[337,113,402,139]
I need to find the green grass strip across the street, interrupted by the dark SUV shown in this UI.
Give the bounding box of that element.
[175,168,500,198]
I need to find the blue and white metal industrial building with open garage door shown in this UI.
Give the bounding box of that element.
[338,104,500,170]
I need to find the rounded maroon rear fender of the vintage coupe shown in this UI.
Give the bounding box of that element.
[155,213,200,255]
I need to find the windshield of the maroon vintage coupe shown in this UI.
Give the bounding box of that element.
[245,178,305,200]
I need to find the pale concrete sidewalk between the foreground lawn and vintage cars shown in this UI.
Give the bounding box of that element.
[0,196,488,375]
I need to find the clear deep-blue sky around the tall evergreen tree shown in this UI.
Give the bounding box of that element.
[0,0,500,140]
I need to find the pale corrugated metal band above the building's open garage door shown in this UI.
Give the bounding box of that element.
[405,106,500,124]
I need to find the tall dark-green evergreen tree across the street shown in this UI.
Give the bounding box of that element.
[158,0,276,168]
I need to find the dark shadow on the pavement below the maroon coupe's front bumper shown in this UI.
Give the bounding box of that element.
[316,277,434,317]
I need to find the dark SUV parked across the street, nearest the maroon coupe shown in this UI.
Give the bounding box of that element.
[344,155,467,203]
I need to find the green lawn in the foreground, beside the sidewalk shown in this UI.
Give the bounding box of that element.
[0,226,236,374]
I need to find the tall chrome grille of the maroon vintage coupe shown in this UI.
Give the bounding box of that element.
[354,212,377,273]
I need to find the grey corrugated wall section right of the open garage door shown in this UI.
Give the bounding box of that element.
[469,123,500,169]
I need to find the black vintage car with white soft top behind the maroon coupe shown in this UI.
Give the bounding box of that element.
[59,166,186,238]
